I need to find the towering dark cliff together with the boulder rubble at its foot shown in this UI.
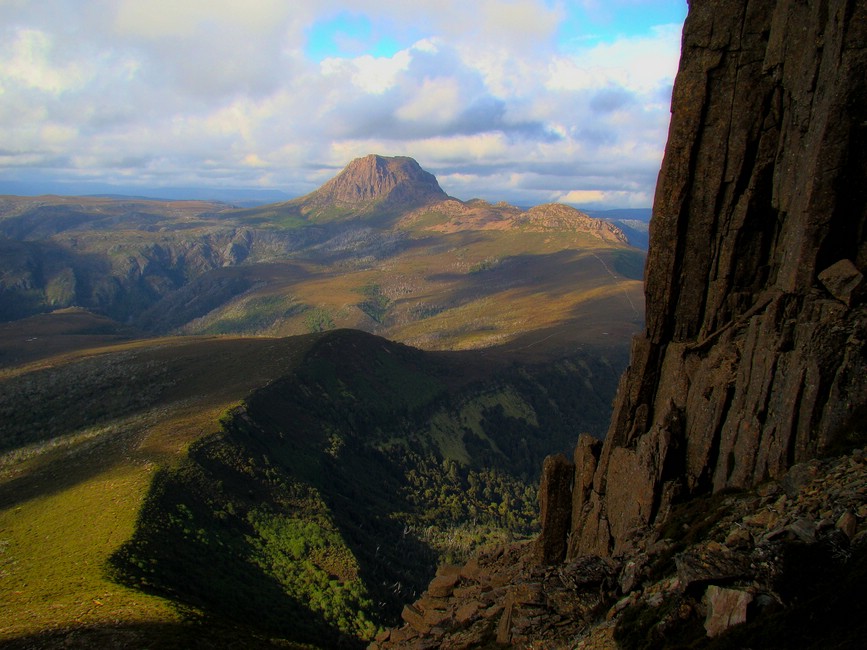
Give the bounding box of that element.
[374,0,867,649]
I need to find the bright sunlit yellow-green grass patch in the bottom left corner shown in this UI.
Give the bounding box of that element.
[0,463,180,639]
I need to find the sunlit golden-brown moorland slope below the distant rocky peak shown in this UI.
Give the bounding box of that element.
[184,224,644,350]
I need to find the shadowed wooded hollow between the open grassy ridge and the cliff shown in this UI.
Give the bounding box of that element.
[105,331,616,647]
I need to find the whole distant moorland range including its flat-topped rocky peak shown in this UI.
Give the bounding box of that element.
[0,155,644,361]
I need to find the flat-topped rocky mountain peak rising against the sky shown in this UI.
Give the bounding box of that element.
[310,154,448,208]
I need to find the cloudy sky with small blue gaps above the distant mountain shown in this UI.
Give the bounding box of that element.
[0,0,687,209]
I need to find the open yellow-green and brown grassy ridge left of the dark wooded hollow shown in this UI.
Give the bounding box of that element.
[0,332,322,639]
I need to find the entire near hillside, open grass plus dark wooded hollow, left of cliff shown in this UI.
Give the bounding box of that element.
[0,332,617,645]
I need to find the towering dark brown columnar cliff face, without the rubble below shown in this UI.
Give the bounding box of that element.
[568,0,867,557]
